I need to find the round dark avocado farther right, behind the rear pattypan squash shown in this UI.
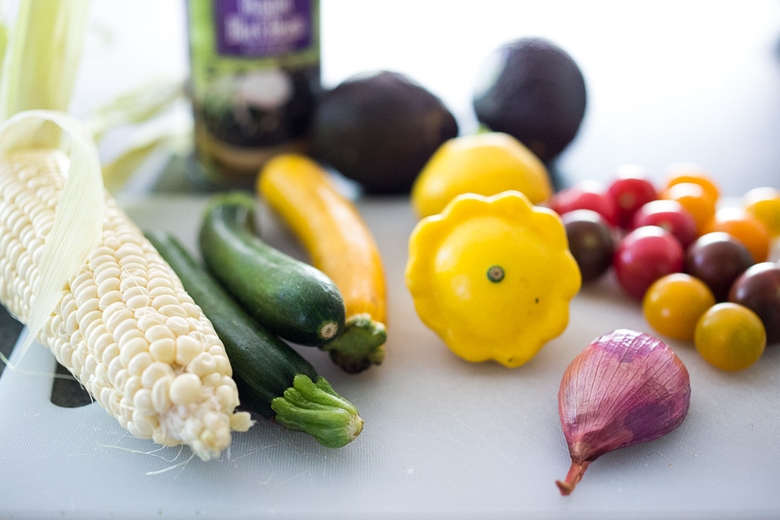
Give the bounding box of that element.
[473,38,587,164]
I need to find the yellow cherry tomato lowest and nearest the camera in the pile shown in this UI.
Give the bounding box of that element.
[694,302,766,371]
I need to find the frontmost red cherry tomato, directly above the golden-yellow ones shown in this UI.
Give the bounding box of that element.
[612,226,684,300]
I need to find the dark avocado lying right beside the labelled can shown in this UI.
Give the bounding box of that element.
[309,70,458,194]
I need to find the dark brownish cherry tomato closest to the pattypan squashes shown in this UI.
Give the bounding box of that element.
[561,209,615,283]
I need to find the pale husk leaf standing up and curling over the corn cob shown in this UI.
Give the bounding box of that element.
[0,0,99,366]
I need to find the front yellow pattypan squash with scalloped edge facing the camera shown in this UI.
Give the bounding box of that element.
[406,191,582,367]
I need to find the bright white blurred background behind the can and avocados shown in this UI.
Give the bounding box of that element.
[65,0,780,196]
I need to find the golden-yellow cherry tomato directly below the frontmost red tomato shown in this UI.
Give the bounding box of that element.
[642,273,716,341]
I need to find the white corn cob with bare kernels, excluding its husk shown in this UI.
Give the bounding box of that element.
[0,150,251,460]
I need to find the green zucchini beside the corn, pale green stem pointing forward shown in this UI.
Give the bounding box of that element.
[145,230,363,448]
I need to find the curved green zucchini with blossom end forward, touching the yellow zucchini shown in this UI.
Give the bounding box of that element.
[199,192,346,347]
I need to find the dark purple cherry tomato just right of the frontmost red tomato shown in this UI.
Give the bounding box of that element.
[684,231,754,302]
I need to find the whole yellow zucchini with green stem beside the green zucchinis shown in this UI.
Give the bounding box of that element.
[257,154,387,373]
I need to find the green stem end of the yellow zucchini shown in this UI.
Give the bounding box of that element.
[320,313,387,374]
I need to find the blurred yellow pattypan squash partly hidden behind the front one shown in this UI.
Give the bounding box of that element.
[411,132,553,218]
